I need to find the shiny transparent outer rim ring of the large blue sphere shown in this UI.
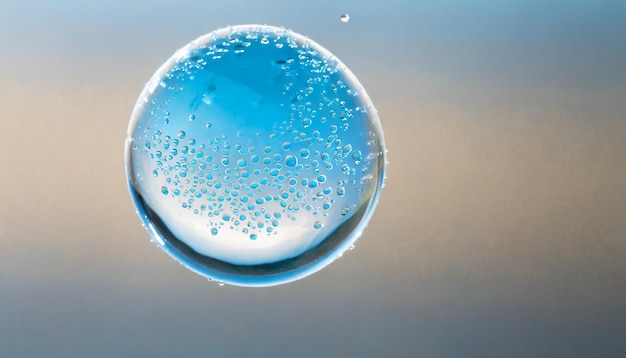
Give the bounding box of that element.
[124,24,387,287]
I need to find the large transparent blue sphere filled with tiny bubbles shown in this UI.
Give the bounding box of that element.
[125,25,385,286]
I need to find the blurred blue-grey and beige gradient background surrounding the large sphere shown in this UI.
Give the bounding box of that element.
[0,0,626,357]
